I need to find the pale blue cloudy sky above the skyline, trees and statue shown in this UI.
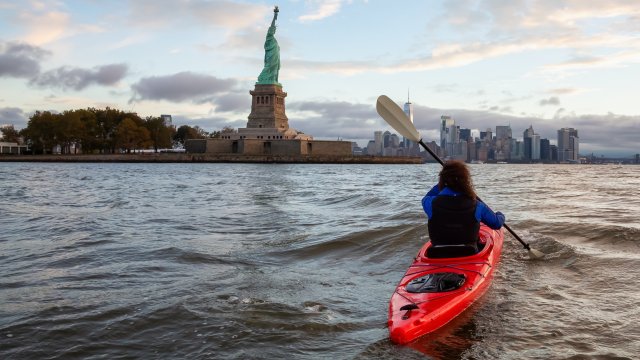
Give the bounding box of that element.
[0,0,640,157]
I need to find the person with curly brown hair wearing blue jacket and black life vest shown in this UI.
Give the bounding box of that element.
[422,160,505,257]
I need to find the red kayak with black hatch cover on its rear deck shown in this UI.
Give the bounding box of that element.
[387,224,504,344]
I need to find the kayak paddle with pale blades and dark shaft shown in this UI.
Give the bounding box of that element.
[376,95,544,259]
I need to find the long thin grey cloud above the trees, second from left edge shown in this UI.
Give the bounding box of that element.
[30,64,129,91]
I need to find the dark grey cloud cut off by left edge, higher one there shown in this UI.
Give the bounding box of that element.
[0,42,50,78]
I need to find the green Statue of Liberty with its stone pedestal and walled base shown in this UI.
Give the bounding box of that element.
[185,6,421,163]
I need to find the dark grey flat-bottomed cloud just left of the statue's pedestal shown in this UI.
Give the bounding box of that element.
[129,72,237,103]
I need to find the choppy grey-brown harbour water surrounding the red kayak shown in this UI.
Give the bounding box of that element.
[0,163,640,359]
